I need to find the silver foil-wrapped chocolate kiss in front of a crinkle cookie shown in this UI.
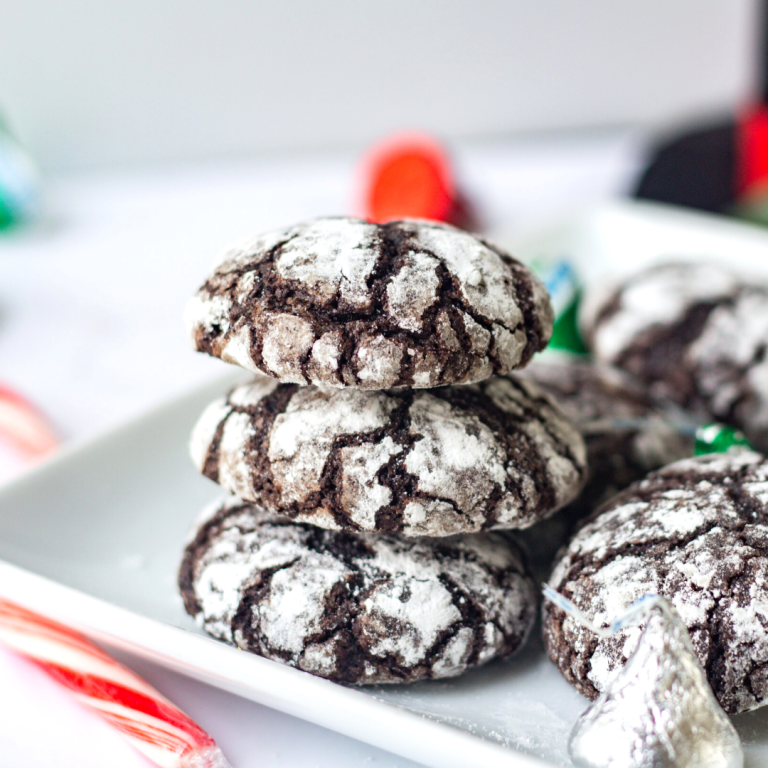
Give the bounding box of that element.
[544,596,744,768]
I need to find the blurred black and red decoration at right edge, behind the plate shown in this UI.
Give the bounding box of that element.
[635,0,768,216]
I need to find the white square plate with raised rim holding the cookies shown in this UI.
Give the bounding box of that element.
[0,204,768,768]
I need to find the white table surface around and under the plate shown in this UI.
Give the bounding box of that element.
[0,132,640,768]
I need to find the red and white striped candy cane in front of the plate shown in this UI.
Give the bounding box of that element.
[0,598,228,768]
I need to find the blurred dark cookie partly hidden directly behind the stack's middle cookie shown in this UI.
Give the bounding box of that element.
[520,360,693,520]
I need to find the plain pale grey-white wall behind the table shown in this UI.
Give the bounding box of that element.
[0,0,758,170]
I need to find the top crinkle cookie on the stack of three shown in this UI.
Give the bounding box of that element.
[185,218,553,389]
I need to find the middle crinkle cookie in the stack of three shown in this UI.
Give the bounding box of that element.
[190,377,586,536]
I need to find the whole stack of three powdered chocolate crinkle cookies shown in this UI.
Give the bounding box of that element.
[180,218,586,684]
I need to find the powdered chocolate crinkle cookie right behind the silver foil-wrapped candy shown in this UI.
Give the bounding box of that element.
[544,452,768,714]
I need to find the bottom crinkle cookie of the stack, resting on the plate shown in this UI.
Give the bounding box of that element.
[179,497,536,685]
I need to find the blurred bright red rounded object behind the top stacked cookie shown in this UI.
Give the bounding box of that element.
[361,133,469,226]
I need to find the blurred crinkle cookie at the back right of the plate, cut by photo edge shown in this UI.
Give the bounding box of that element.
[582,262,768,450]
